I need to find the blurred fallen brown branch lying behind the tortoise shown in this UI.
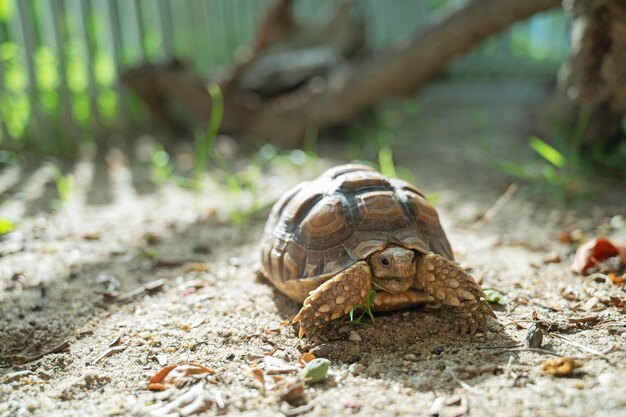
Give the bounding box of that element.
[122,0,560,146]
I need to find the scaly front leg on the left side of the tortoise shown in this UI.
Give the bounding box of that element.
[292,261,372,337]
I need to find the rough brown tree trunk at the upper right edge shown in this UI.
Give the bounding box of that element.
[560,0,626,149]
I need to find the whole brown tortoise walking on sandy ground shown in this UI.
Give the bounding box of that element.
[260,164,495,337]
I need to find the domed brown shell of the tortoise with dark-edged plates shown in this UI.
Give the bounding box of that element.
[261,164,453,301]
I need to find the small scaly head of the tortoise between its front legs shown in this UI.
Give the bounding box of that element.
[369,246,416,293]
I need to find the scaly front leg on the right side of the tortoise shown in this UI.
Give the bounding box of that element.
[417,253,496,334]
